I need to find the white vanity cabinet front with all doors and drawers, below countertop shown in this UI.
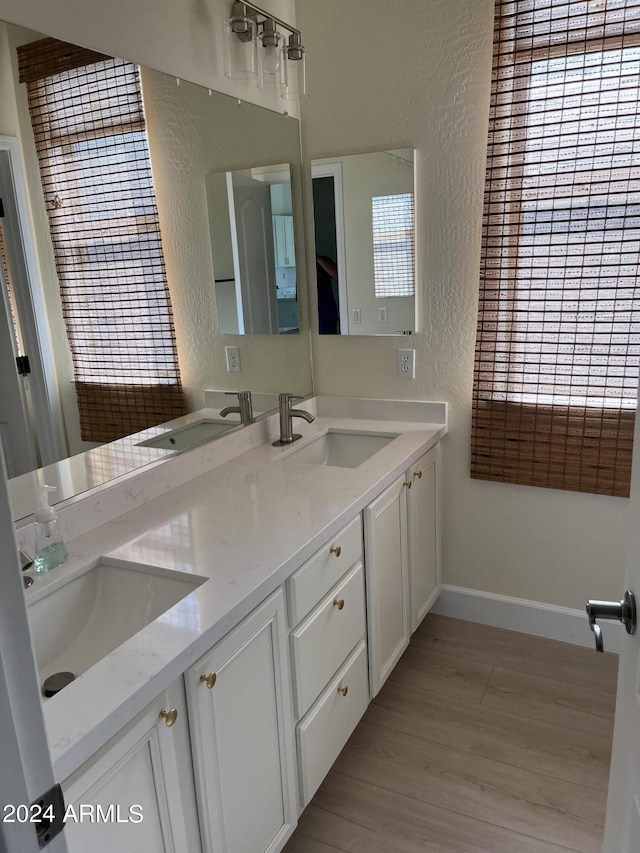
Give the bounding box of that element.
[53,432,440,853]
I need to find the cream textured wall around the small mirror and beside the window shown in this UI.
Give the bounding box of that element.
[297,0,629,608]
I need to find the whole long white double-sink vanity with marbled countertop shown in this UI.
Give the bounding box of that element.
[19,398,446,853]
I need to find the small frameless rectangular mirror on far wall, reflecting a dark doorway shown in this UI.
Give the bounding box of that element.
[311,148,416,335]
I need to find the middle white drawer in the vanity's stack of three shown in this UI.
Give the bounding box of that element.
[291,562,366,719]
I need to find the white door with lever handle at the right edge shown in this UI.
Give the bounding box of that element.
[603,402,640,853]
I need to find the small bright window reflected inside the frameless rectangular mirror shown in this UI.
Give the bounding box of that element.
[371,193,415,298]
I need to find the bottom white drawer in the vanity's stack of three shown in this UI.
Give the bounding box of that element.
[296,642,369,808]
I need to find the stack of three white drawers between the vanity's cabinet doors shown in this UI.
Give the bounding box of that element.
[287,515,369,808]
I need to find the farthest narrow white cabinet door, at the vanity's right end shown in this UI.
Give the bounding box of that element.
[407,445,440,633]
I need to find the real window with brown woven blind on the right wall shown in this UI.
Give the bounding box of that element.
[471,0,640,497]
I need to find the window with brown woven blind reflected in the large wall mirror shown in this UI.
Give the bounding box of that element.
[18,39,185,442]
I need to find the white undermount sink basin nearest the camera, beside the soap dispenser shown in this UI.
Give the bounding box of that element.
[28,558,206,695]
